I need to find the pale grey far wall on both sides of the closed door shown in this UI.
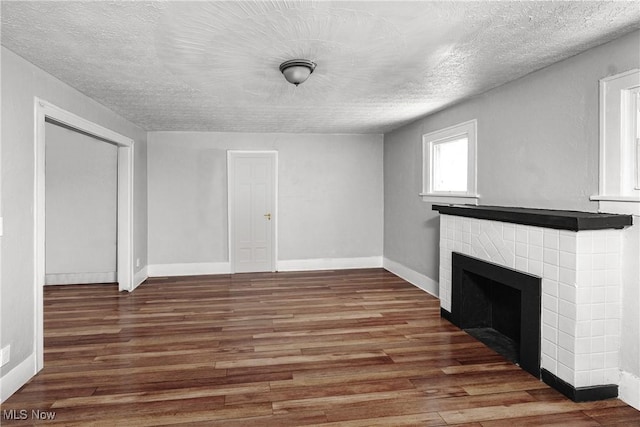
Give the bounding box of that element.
[148,132,383,265]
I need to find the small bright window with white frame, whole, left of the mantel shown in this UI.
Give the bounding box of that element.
[420,120,478,204]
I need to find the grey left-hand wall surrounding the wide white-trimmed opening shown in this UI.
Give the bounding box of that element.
[0,47,147,395]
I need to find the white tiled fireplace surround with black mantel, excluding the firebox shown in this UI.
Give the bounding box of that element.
[433,206,631,400]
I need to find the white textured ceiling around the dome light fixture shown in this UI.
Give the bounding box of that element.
[1,0,640,133]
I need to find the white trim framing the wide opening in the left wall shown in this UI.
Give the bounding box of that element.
[33,97,135,372]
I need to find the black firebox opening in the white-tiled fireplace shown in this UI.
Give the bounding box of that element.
[447,252,541,378]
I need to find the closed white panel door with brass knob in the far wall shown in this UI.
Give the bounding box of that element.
[228,151,277,273]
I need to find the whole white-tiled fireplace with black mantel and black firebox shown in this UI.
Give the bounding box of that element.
[433,205,632,401]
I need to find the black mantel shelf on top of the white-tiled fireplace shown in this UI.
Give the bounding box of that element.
[432,205,633,231]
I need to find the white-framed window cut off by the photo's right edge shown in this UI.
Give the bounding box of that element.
[590,69,640,215]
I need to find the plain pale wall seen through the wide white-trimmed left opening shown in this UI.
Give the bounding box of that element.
[45,123,118,284]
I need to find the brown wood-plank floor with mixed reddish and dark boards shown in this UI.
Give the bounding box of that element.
[2,269,640,427]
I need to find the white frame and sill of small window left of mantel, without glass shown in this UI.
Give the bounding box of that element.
[420,119,480,205]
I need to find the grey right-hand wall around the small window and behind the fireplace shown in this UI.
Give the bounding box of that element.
[384,31,640,402]
